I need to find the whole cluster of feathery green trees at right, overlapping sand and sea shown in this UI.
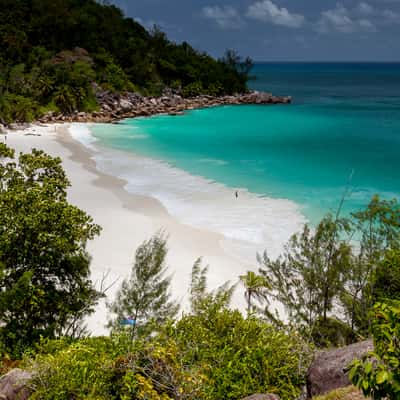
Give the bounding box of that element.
[259,196,400,346]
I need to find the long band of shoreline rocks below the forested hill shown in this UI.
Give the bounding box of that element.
[38,90,292,123]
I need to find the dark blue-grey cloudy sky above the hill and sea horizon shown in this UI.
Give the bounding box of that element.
[112,0,400,61]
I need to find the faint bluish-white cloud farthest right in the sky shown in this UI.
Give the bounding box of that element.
[316,3,377,33]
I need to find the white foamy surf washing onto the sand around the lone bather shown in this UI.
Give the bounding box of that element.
[71,124,306,262]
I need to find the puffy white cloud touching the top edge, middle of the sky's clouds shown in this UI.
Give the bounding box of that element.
[246,0,305,28]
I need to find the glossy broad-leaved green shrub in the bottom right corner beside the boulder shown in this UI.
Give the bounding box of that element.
[350,301,400,400]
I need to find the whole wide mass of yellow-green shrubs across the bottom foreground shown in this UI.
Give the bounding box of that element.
[26,264,312,400]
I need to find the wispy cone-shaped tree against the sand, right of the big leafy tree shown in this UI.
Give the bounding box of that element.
[108,233,179,335]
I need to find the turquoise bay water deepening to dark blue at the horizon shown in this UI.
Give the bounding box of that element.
[92,64,400,222]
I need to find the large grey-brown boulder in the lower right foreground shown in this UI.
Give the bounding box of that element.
[307,340,374,398]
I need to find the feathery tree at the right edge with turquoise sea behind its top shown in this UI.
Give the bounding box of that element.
[341,196,400,336]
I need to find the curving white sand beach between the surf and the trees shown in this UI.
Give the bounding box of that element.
[3,125,301,335]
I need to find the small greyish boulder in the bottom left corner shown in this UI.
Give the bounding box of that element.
[0,368,32,400]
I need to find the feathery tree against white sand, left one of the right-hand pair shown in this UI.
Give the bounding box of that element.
[258,215,351,331]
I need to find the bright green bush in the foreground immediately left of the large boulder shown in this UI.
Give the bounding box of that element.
[170,309,310,400]
